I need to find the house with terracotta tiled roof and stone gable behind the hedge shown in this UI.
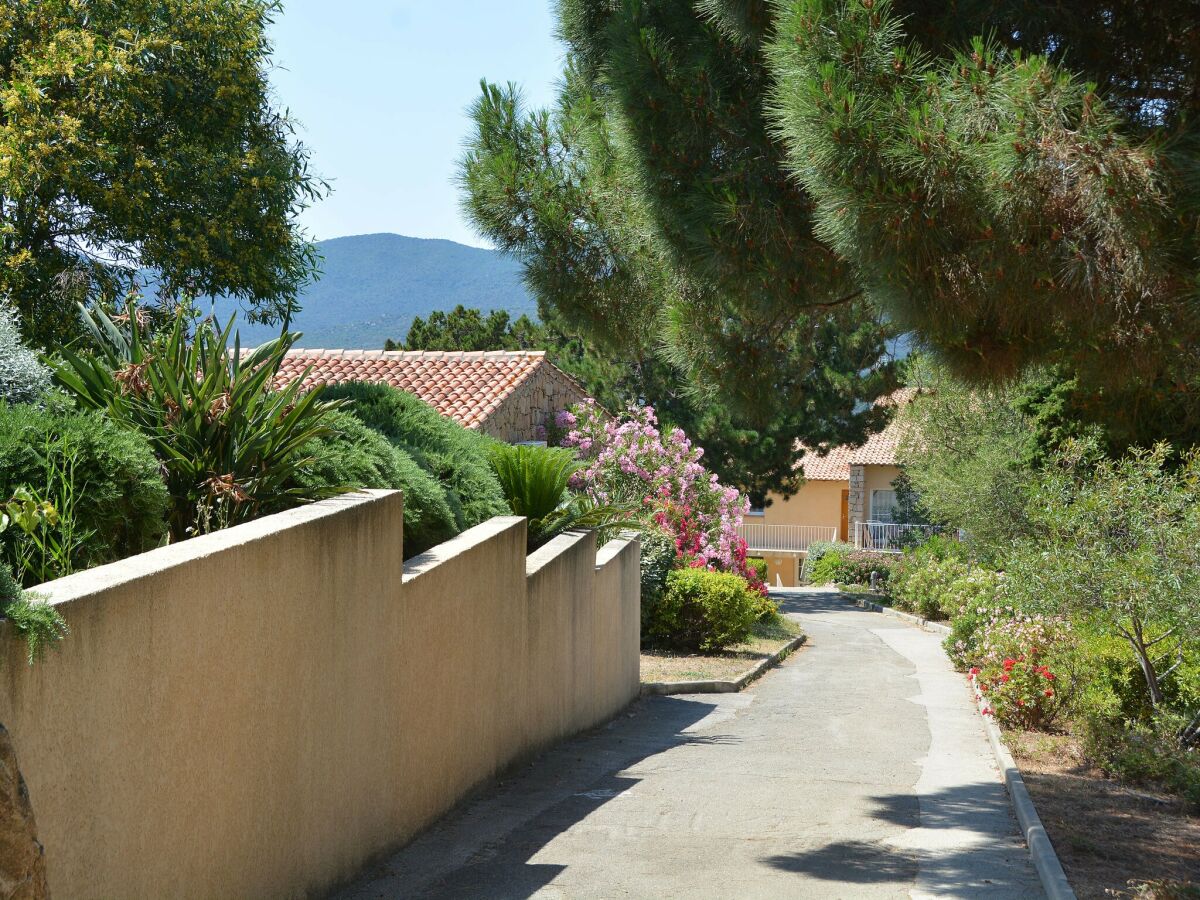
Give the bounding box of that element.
[276,349,588,444]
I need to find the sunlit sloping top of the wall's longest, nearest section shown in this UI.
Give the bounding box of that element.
[30,490,403,606]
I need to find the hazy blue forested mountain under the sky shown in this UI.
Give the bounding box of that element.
[214,234,538,350]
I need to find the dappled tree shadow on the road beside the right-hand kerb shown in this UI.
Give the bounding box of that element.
[762,782,1039,896]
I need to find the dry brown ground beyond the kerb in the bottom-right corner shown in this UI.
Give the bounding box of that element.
[1004,730,1200,900]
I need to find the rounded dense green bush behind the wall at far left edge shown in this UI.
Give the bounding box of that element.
[0,402,169,584]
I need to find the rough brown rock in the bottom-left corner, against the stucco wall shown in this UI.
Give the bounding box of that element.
[0,725,50,900]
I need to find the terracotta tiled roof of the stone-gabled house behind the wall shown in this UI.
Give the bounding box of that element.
[275,349,568,428]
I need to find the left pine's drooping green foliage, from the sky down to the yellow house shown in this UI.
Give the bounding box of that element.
[461,56,894,496]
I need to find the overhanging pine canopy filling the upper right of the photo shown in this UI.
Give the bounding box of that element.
[463,0,1200,446]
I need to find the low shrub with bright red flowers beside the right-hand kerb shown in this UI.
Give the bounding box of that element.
[971,614,1070,728]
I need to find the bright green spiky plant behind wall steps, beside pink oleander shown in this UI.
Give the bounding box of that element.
[488,444,641,551]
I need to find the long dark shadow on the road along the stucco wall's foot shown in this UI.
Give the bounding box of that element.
[330,696,738,900]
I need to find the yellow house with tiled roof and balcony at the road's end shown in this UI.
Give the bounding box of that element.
[742,390,912,587]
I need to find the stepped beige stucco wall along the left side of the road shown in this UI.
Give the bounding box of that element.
[0,492,638,898]
